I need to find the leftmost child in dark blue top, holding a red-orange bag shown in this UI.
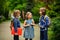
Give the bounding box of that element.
[10,10,20,40]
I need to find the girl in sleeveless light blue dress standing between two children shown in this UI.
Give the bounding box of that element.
[24,12,35,40]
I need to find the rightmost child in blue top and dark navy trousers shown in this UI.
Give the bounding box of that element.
[39,7,50,40]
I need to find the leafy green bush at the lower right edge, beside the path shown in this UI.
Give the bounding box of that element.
[52,17,60,40]
